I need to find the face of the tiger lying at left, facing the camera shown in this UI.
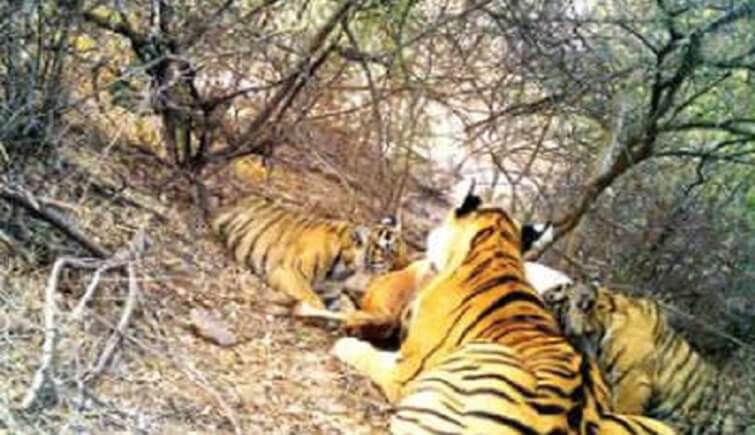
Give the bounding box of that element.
[355,215,409,273]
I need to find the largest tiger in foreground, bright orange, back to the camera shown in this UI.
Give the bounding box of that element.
[333,187,674,435]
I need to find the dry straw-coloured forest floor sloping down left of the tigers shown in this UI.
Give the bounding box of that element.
[0,141,446,434]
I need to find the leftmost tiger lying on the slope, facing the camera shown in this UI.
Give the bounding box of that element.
[212,195,408,310]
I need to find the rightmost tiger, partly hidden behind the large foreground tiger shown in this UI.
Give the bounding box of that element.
[544,282,745,435]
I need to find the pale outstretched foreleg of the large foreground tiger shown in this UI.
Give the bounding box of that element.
[332,337,400,402]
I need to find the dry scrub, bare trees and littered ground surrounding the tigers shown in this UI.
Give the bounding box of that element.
[0,0,755,434]
